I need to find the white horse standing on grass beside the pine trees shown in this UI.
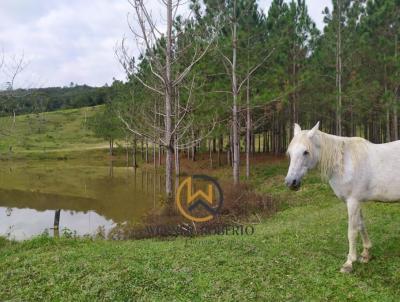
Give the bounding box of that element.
[285,122,400,273]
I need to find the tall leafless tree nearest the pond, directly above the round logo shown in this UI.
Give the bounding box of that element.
[116,0,212,199]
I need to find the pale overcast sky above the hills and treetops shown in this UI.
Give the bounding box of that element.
[0,0,331,87]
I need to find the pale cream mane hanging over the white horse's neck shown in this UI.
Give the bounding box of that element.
[317,131,369,181]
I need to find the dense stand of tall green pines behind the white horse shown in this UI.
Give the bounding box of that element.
[99,0,400,194]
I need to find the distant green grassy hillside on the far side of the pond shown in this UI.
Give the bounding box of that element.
[0,106,107,154]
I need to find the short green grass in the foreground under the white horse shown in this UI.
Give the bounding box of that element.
[0,163,400,301]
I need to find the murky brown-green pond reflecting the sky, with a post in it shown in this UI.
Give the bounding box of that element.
[0,161,164,240]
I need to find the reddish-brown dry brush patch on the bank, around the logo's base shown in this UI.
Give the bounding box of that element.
[108,183,281,240]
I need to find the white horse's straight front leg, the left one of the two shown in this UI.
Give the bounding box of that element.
[340,199,360,273]
